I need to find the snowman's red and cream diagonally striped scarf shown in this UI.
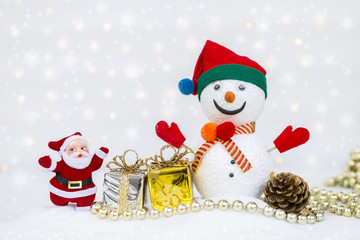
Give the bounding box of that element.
[191,122,255,173]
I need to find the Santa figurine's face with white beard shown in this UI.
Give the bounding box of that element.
[62,139,91,169]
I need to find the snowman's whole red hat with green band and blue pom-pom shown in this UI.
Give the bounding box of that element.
[179,40,267,100]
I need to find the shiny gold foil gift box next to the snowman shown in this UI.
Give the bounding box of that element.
[148,164,193,211]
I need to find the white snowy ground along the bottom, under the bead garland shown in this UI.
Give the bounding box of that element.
[0,204,360,240]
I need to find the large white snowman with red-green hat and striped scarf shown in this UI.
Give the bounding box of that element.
[179,41,309,199]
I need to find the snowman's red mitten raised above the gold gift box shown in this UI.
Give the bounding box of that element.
[155,121,186,148]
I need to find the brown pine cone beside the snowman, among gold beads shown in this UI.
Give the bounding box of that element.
[264,173,310,213]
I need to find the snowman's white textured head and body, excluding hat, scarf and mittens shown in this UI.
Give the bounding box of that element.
[193,79,274,198]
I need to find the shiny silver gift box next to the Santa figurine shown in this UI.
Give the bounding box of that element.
[103,172,149,210]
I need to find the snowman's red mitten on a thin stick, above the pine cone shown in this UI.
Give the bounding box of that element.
[268,126,310,153]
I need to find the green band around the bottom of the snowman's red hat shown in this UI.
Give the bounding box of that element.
[197,64,267,101]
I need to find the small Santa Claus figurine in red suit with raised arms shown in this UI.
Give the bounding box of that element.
[39,132,109,210]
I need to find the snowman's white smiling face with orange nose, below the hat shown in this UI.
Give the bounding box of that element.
[200,79,265,126]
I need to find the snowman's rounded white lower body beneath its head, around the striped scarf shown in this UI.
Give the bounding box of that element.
[193,133,274,198]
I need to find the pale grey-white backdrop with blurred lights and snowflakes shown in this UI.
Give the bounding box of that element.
[0,0,360,221]
